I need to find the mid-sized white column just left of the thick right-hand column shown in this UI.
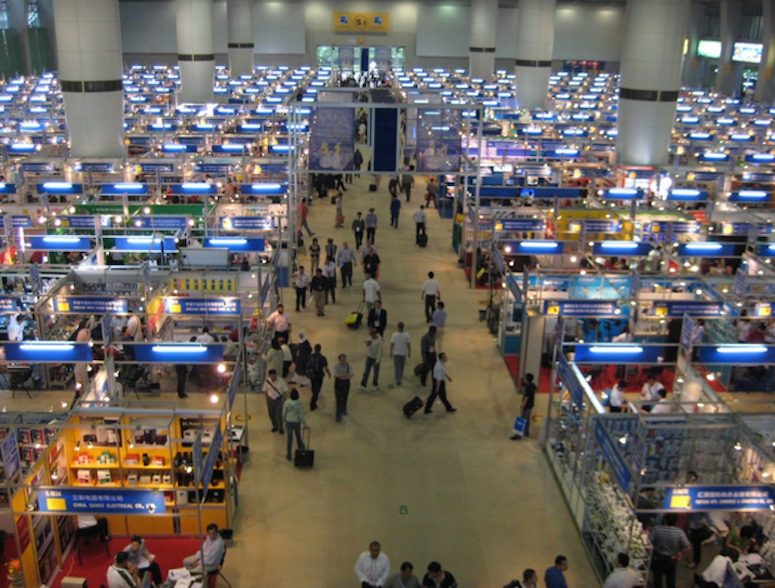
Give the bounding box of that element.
[514,0,556,108]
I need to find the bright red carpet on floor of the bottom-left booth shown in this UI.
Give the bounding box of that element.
[51,537,198,588]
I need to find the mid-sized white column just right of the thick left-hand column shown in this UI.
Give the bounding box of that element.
[175,0,215,104]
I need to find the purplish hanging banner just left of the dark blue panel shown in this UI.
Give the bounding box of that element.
[309,107,355,171]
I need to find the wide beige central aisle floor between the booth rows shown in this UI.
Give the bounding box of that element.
[224,176,597,588]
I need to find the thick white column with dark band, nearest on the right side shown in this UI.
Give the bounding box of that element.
[616,0,690,165]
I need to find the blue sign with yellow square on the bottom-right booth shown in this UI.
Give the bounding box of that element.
[662,484,775,512]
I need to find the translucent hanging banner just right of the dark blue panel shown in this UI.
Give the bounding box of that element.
[417,110,461,172]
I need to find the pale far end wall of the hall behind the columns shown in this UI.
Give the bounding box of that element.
[120,0,624,71]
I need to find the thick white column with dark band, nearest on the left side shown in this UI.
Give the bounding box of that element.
[54,0,124,157]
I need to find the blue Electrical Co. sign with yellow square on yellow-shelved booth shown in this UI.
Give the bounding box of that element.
[38,486,167,515]
